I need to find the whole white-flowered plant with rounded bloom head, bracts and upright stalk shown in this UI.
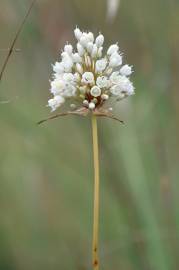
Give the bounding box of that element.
[39,28,134,270]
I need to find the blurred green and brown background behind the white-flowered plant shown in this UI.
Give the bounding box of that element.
[0,0,179,270]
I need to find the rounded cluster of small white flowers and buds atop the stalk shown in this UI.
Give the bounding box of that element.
[48,28,134,111]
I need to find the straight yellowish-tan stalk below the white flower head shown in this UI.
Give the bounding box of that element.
[92,114,99,270]
